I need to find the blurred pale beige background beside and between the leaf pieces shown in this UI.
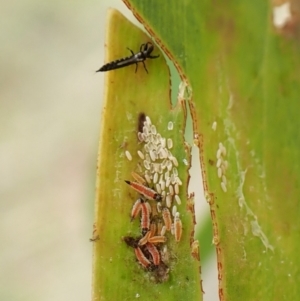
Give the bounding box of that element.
[0,0,217,301]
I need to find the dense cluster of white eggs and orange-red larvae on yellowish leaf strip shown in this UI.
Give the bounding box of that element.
[125,116,182,268]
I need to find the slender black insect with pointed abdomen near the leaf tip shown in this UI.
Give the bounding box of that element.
[96,42,159,73]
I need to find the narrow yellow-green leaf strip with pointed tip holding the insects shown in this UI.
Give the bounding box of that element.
[93,10,201,301]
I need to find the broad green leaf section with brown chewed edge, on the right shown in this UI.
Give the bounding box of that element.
[124,0,300,300]
